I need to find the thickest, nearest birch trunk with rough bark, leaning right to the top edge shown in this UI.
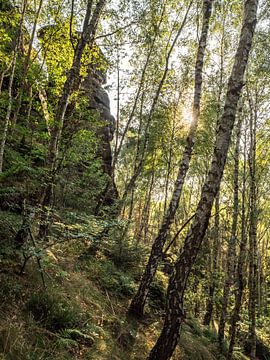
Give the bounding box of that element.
[148,0,258,360]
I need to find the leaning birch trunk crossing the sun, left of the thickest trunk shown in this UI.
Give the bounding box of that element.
[129,0,212,316]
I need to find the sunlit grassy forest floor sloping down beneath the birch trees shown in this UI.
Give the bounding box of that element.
[0,210,264,360]
